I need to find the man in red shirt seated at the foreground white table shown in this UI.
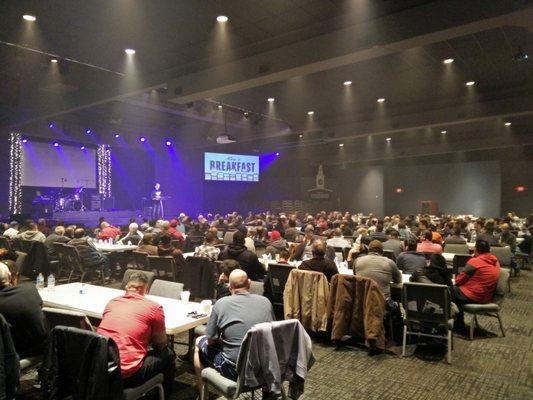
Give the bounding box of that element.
[98,272,175,399]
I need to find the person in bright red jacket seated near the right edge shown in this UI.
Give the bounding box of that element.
[452,240,500,331]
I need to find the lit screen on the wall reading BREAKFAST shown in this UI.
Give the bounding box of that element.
[204,153,259,182]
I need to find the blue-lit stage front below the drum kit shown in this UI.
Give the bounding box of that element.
[53,210,143,227]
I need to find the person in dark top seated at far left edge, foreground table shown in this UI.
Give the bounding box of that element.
[0,263,48,358]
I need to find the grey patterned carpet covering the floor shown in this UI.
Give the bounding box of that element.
[18,271,533,400]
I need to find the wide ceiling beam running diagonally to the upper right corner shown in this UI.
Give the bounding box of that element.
[167,0,533,104]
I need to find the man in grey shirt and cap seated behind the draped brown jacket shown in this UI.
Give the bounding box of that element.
[354,240,402,299]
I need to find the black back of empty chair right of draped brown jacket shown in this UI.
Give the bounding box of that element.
[402,282,450,325]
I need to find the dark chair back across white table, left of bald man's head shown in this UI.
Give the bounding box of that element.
[183,256,218,299]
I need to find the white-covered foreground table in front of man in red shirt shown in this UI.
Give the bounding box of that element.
[39,282,209,335]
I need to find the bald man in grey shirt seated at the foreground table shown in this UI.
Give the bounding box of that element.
[194,269,274,393]
